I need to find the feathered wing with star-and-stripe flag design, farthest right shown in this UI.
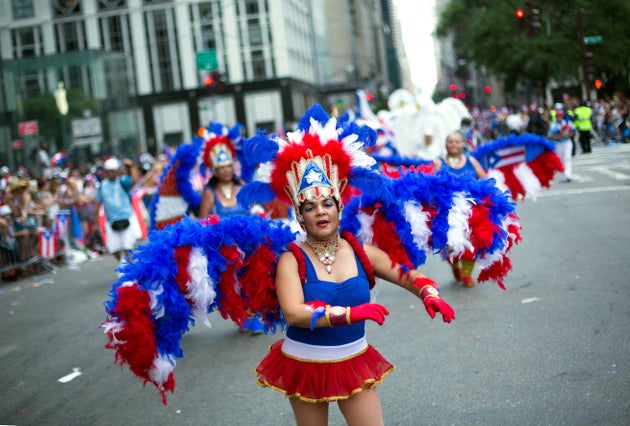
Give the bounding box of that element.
[472,133,564,200]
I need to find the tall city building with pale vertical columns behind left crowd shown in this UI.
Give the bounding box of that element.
[0,0,400,171]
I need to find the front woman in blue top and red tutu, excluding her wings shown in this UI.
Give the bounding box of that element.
[255,131,455,426]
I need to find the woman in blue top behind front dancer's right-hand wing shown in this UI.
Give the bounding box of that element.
[434,132,488,287]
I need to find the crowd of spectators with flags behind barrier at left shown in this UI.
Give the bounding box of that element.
[0,150,167,280]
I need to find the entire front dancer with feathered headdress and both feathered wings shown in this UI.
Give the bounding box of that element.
[101,105,520,410]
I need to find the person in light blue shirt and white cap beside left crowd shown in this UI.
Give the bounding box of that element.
[94,157,140,266]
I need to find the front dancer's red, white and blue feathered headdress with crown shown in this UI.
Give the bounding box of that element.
[238,104,380,211]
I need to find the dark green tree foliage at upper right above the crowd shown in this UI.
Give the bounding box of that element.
[436,0,630,98]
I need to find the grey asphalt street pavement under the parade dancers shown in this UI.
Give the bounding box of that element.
[0,145,630,426]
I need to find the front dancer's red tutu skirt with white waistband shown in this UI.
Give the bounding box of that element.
[254,338,394,402]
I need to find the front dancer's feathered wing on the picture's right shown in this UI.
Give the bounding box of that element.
[342,170,521,289]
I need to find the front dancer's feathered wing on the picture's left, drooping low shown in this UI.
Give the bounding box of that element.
[101,215,295,404]
